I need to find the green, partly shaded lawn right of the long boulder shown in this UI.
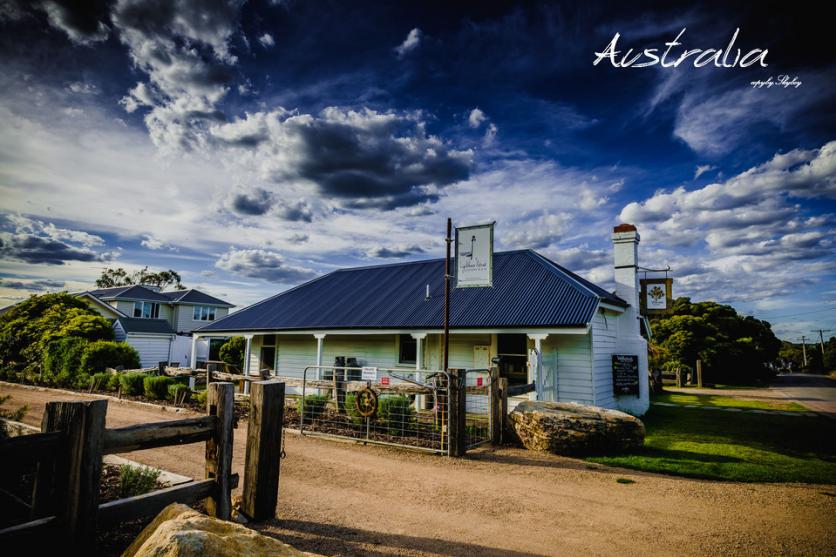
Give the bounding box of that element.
[587,406,836,484]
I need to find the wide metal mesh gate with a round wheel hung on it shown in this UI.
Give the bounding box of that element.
[298,366,450,453]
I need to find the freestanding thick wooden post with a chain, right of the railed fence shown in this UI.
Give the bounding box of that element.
[241,381,285,520]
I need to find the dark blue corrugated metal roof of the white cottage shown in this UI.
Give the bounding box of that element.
[199,250,627,332]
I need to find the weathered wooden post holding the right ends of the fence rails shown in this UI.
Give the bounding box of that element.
[206,382,235,520]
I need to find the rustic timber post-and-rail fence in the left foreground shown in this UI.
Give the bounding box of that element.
[0,381,284,547]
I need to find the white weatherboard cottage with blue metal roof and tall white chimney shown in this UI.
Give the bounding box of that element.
[198,224,649,415]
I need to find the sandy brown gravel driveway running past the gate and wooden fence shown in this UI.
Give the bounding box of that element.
[0,385,836,556]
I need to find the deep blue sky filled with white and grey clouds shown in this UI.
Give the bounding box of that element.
[0,0,836,339]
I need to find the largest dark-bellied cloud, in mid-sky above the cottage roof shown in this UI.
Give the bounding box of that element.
[211,107,473,210]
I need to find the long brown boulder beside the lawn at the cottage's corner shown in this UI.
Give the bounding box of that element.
[509,400,644,455]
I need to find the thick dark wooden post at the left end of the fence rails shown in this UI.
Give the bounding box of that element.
[32,400,107,546]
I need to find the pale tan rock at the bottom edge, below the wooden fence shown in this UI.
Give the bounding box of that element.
[122,503,314,557]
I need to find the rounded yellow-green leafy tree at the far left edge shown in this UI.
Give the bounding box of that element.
[0,292,113,368]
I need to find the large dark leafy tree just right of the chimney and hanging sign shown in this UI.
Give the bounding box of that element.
[652,297,782,384]
